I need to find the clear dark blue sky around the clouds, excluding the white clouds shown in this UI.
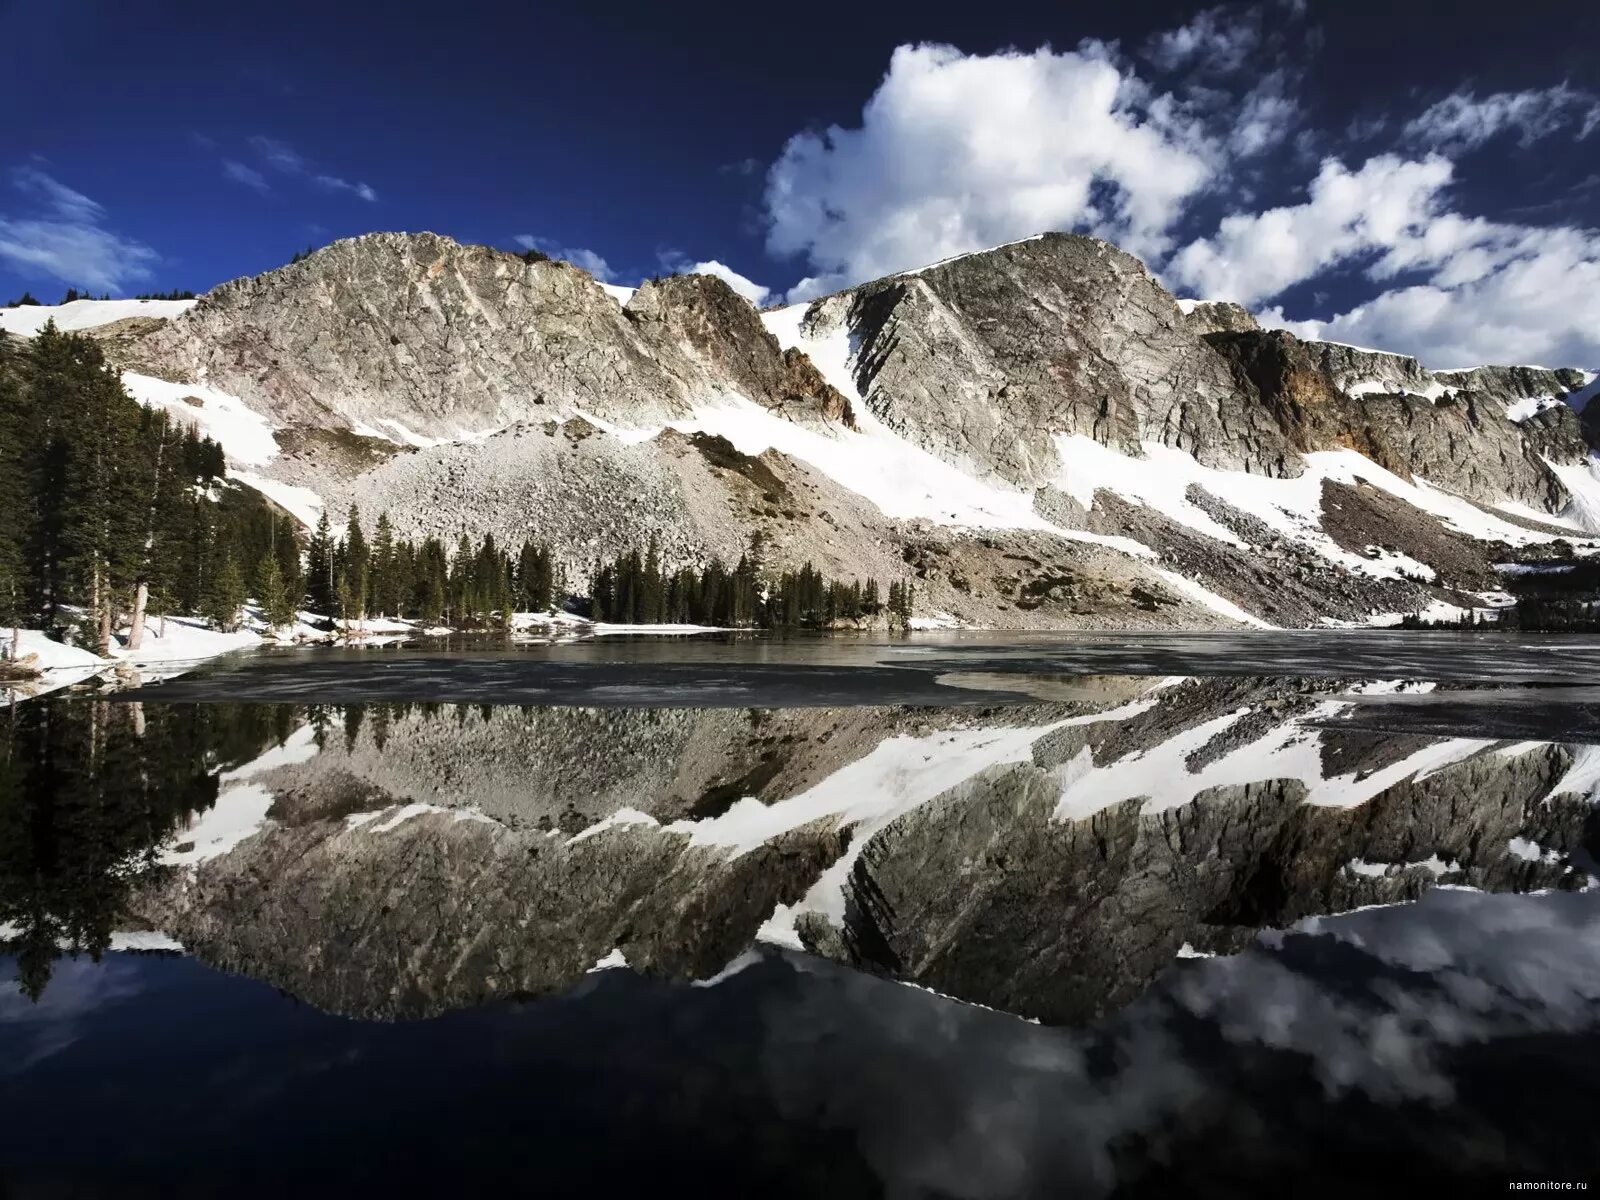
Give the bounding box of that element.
[0,0,1600,366]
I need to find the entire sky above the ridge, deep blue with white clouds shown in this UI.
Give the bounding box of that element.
[0,0,1600,366]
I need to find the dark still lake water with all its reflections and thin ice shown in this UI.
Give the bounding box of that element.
[0,635,1600,1197]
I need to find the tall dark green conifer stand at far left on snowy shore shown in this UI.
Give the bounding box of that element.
[0,323,299,653]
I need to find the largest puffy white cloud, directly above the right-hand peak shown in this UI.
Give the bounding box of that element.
[765,42,1219,299]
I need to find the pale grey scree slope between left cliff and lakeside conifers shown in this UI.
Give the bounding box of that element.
[315,418,1232,629]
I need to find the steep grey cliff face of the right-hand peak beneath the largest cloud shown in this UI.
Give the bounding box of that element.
[806,234,1298,486]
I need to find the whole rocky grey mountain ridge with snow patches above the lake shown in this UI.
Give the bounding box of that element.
[15,234,1600,627]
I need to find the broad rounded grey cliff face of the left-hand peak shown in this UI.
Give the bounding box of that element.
[136,234,843,438]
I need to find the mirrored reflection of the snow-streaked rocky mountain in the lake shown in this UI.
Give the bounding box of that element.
[0,677,1600,1024]
